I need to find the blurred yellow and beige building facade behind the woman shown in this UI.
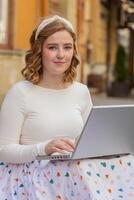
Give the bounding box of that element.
[0,0,133,99]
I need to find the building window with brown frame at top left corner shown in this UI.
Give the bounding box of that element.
[0,0,13,49]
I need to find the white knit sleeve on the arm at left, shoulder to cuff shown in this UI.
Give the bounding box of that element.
[0,85,47,163]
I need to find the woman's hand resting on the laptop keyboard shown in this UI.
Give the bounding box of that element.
[45,137,75,155]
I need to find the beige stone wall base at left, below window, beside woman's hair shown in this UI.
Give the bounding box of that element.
[0,50,24,103]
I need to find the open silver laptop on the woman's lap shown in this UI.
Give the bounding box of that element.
[37,105,134,160]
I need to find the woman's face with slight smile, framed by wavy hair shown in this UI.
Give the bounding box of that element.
[42,30,74,76]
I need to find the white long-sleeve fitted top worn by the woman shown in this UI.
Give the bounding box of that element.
[0,80,92,163]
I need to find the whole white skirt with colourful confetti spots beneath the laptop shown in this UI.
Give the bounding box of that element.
[0,155,134,200]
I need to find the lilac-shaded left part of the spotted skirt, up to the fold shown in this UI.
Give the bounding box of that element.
[0,160,90,200]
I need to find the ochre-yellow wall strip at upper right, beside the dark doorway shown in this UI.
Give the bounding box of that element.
[90,0,107,63]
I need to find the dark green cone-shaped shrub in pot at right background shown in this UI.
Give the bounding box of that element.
[114,45,129,81]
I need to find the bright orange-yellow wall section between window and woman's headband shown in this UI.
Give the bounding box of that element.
[14,0,47,49]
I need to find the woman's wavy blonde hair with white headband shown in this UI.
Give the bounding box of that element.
[21,15,80,84]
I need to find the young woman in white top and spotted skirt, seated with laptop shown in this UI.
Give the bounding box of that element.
[0,16,92,200]
